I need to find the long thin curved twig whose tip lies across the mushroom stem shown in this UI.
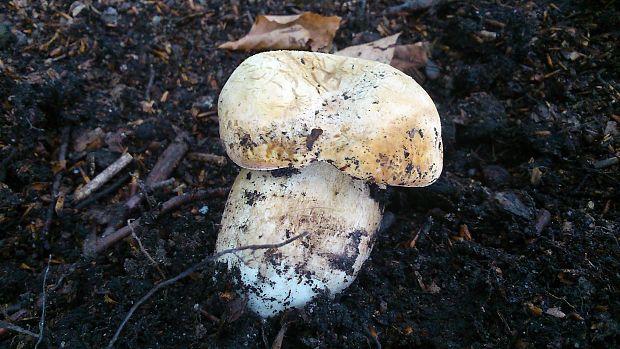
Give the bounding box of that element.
[108,231,310,349]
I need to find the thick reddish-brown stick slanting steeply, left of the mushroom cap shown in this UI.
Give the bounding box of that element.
[103,132,189,236]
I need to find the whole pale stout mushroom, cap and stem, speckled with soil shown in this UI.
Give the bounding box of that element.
[216,51,443,317]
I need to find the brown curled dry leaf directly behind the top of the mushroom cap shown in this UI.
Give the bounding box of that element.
[219,12,340,51]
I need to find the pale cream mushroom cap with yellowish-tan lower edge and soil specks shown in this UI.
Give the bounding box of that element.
[218,51,443,187]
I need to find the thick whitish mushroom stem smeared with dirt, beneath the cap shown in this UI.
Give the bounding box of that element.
[216,162,381,317]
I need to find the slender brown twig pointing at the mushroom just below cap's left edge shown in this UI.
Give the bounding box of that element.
[84,189,222,256]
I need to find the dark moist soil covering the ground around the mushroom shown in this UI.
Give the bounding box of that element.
[0,0,620,348]
